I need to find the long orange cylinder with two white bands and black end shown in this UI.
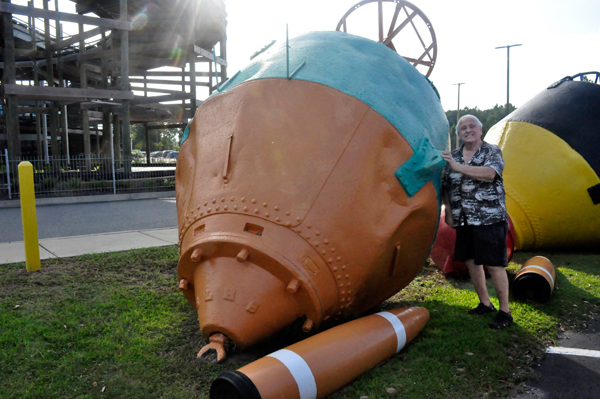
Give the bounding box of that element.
[210,307,429,399]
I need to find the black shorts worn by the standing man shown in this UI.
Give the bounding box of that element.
[454,221,508,267]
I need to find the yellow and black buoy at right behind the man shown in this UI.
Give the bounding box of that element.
[485,72,600,250]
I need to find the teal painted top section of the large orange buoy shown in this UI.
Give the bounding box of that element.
[182,32,448,196]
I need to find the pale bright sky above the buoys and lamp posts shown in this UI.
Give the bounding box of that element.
[225,0,600,110]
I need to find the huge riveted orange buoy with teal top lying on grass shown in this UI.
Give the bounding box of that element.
[176,32,448,359]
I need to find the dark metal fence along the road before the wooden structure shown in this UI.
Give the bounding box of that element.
[0,151,177,200]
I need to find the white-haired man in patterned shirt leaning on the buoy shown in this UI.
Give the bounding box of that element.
[442,115,513,330]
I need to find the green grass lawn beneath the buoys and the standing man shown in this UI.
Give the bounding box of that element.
[0,247,600,399]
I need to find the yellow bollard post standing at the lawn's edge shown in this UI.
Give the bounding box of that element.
[19,161,41,272]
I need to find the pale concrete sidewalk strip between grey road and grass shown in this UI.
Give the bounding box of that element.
[0,228,178,264]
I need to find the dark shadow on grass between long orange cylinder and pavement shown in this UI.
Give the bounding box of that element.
[332,295,541,398]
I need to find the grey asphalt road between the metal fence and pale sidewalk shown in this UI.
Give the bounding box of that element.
[0,198,177,242]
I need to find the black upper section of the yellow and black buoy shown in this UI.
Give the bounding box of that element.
[505,78,600,176]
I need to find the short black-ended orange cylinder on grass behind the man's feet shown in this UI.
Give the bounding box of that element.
[513,256,556,302]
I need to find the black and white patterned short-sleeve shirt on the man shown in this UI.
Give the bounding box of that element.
[442,142,507,227]
